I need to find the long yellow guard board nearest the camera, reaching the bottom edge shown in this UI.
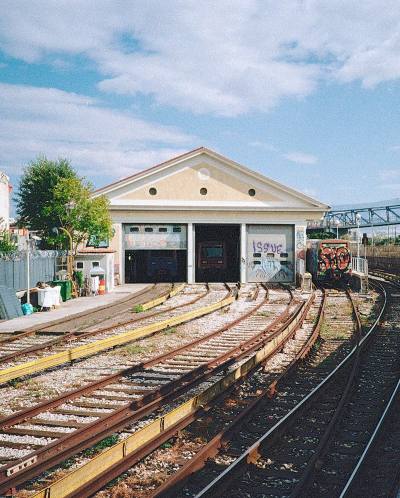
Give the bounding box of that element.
[32,296,312,498]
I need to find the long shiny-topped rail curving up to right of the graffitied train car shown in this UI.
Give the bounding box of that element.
[196,284,387,498]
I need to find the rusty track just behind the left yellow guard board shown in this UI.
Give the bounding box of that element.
[0,286,209,368]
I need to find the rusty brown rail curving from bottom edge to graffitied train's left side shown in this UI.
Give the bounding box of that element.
[149,291,326,498]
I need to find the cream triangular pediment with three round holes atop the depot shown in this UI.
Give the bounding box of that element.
[96,148,328,210]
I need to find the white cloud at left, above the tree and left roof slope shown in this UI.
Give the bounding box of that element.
[0,84,192,177]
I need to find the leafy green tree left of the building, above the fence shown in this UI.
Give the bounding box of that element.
[16,157,112,254]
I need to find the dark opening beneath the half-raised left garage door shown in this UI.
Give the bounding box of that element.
[125,249,186,284]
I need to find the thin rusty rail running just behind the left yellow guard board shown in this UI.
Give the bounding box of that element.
[0,284,210,363]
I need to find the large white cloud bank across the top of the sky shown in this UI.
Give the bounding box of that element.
[0,0,400,116]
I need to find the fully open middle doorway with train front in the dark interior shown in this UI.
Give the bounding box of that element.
[195,225,240,282]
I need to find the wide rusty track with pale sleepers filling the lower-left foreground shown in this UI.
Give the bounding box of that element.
[0,282,304,492]
